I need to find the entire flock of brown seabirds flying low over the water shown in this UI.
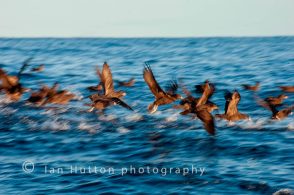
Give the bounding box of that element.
[0,58,294,135]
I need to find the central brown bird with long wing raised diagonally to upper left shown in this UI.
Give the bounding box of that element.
[143,63,182,113]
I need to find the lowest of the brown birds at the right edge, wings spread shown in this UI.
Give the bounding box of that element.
[255,96,294,120]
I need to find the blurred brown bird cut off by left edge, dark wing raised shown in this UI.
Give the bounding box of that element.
[0,60,28,101]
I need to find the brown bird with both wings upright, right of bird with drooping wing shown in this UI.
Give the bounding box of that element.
[215,90,249,121]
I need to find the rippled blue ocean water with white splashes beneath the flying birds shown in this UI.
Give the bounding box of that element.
[0,37,294,194]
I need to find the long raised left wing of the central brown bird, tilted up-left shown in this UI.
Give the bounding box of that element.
[143,63,166,99]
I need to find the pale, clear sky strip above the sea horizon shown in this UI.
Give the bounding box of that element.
[0,0,294,37]
